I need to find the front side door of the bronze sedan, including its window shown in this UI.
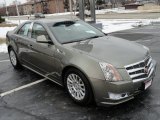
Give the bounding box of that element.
[28,23,59,82]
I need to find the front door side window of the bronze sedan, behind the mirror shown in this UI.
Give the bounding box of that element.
[32,23,50,40]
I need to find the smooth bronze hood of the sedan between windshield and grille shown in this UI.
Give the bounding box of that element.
[65,36,148,68]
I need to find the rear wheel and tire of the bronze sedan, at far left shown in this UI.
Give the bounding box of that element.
[9,48,22,69]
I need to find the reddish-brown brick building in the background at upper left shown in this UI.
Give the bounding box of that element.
[0,0,64,16]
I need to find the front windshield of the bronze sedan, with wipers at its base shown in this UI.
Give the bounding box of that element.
[50,21,104,44]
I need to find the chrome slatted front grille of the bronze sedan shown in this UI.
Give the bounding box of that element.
[125,56,154,82]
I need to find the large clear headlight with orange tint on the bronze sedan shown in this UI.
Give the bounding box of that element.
[99,62,122,81]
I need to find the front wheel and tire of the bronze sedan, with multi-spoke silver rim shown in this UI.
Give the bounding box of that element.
[64,68,93,105]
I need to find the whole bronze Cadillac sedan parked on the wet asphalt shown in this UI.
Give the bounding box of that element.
[7,19,156,105]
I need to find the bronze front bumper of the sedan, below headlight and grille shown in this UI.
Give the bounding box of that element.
[92,61,156,106]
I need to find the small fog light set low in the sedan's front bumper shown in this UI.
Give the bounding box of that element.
[108,92,128,100]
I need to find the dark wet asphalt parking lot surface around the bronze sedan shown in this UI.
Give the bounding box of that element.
[0,24,160,120]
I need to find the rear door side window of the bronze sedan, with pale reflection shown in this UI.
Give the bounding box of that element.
[17,23,31,36]
